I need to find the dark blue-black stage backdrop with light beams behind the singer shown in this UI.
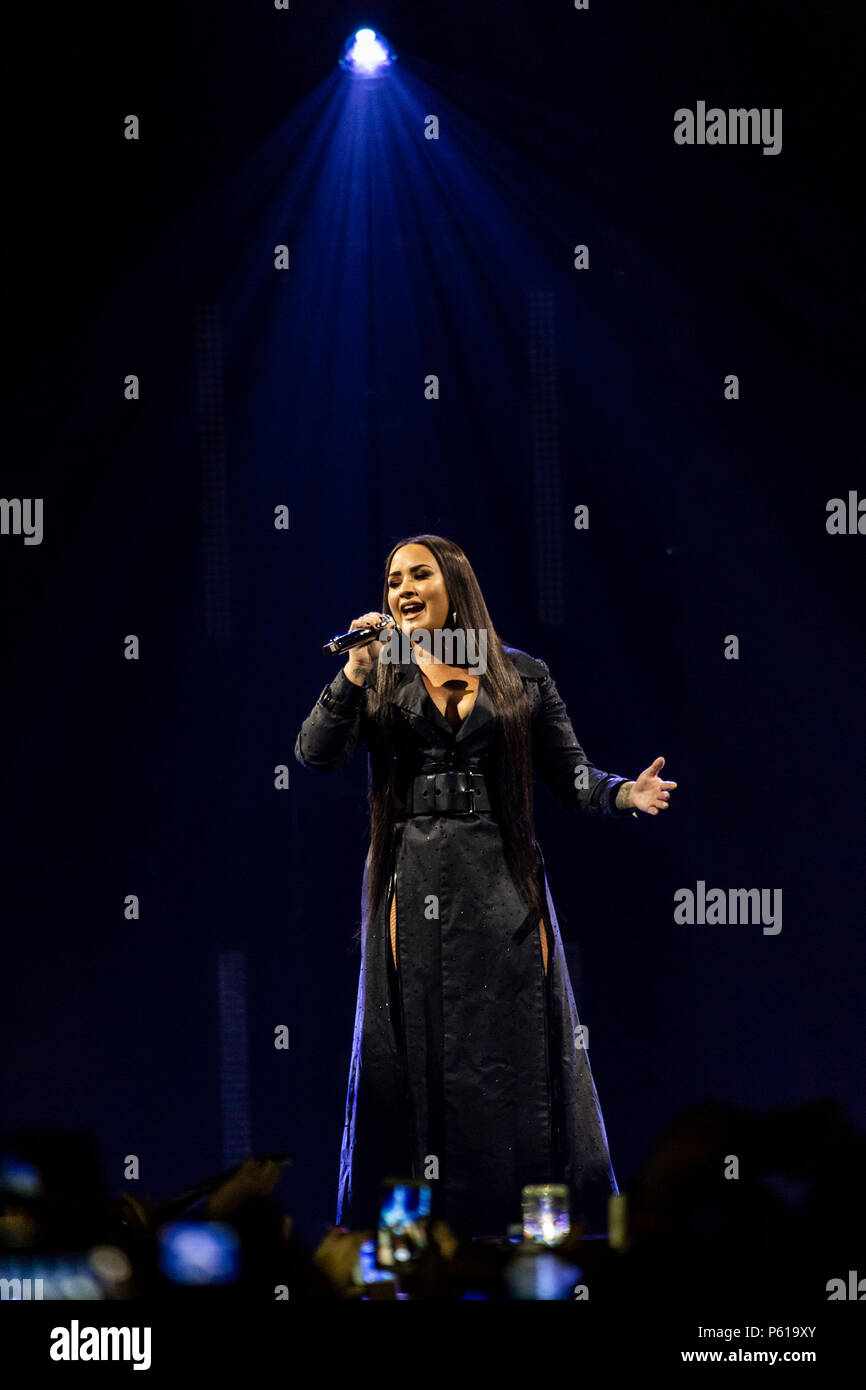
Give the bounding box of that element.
[0,0,866,1251]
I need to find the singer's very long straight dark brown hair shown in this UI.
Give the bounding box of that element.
[364,535,544,924]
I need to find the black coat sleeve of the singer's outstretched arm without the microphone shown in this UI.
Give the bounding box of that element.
[532,662,631,820]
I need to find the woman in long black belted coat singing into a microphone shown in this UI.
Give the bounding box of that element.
[295,535,677,1236]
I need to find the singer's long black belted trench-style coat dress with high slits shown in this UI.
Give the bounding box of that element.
[295,648,628,1236]
